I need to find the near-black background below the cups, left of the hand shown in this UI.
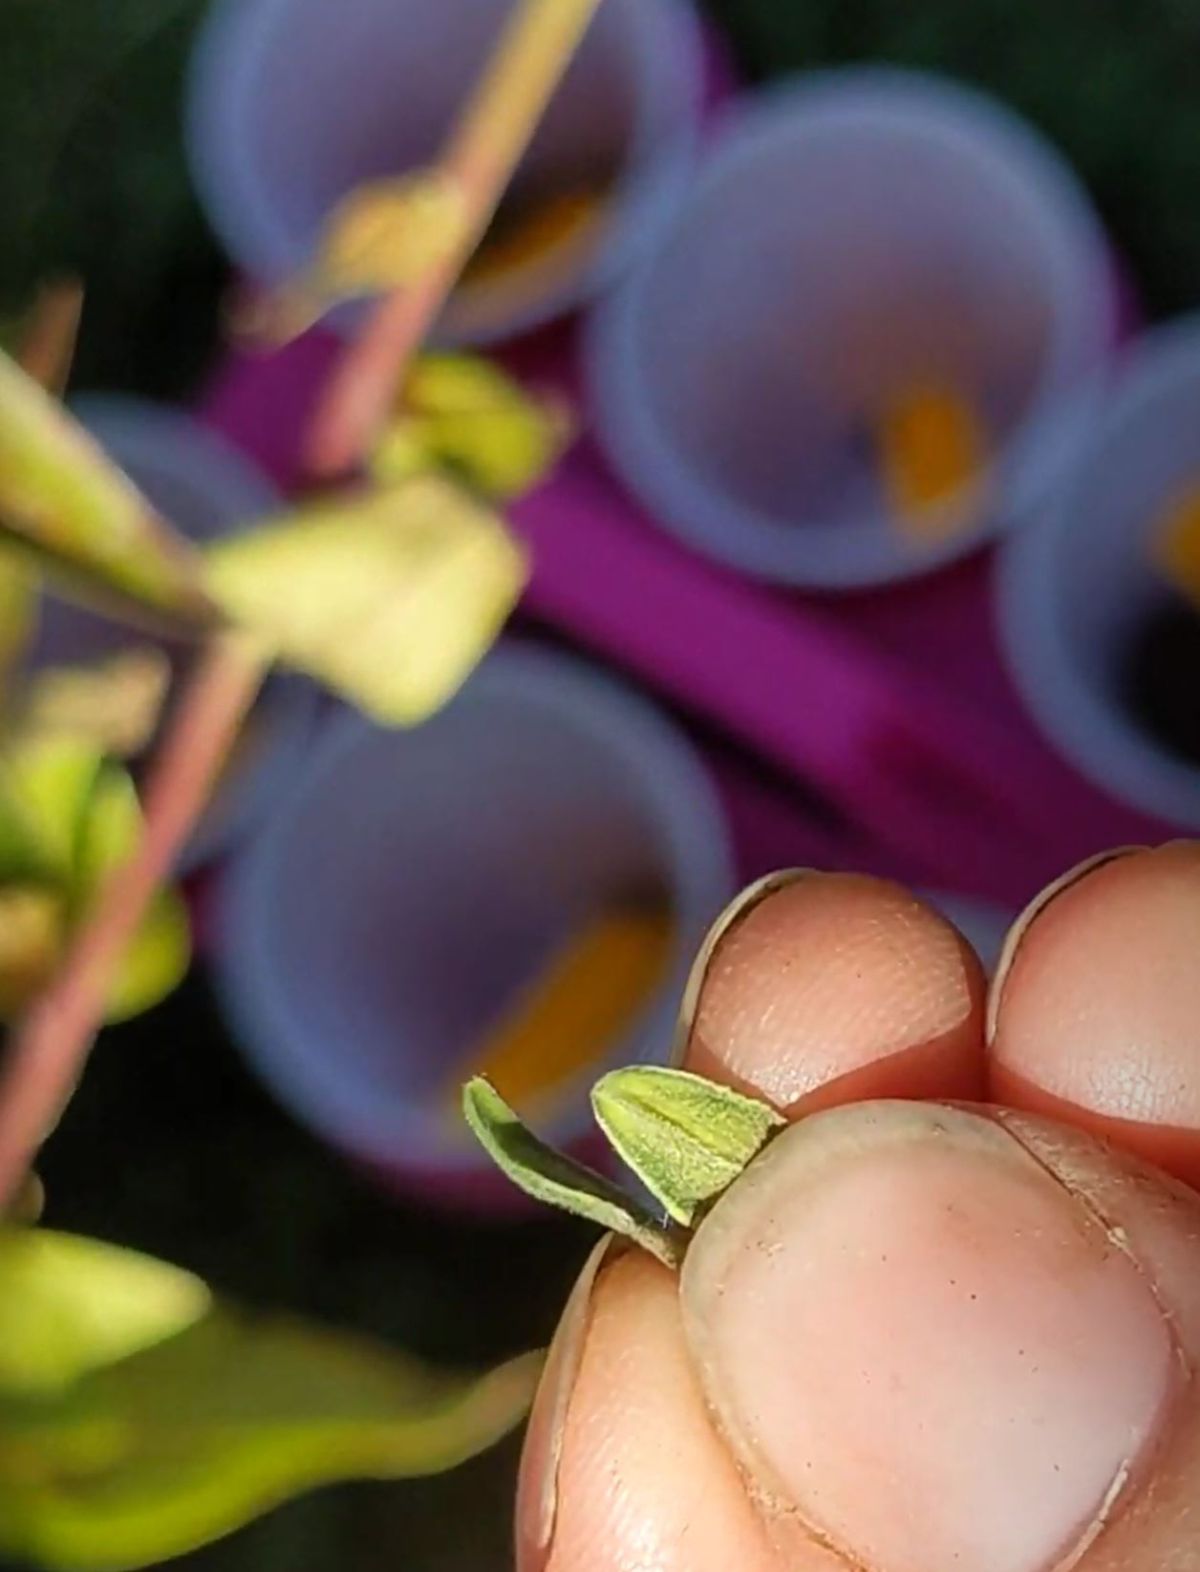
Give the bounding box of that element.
[23,978,591,1572]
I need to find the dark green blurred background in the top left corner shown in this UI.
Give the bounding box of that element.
[0,0,225,398]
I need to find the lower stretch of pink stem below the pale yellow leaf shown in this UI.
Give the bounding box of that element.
[0,634,267,1207]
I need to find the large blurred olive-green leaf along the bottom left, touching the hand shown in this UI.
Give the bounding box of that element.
[0,1269,541,1572]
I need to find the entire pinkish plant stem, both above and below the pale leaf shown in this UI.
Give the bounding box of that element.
[0,0,598,1215]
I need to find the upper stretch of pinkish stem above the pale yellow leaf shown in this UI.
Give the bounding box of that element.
[305,0,598,479]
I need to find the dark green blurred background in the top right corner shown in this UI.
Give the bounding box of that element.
[708,0,1200,314]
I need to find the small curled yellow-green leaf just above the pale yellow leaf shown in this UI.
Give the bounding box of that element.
[371,354,571,500]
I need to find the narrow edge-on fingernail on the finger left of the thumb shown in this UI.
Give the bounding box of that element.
[516,1236,618,1572]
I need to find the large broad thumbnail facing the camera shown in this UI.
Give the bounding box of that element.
[683,1104,1178,1572]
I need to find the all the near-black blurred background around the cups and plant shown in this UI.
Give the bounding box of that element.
[0,0,1200,1572]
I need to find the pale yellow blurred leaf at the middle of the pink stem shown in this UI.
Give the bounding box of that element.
[208,475,525,726]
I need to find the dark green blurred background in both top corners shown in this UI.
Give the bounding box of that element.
[0,0,1200,411]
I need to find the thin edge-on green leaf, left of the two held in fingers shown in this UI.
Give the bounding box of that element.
[462,1075,683,1265]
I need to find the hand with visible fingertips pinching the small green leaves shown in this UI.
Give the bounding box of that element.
[517,844,1200,1572]
